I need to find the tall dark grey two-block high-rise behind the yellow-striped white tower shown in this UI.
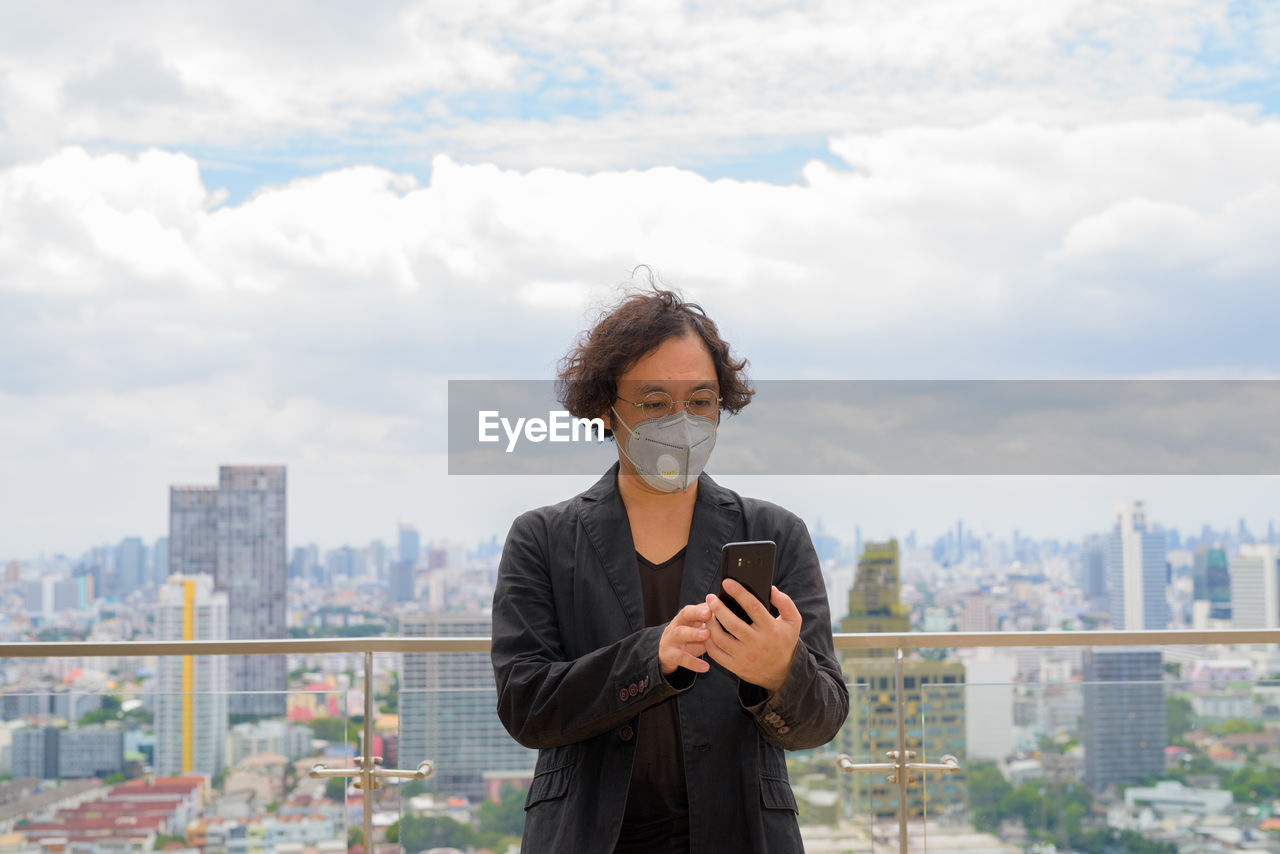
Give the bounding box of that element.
[169,466,288,716]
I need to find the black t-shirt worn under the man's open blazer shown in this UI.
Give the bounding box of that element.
[613,549,689,854]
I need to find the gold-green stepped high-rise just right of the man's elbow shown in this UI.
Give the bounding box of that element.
[840,540,965,817]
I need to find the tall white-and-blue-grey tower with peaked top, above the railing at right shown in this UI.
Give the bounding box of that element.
[1107,501,1169,630]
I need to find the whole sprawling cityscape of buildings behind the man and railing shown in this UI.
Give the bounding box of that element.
[0,465,1280,853]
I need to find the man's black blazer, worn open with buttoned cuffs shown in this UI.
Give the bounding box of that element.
[492,465,849,854]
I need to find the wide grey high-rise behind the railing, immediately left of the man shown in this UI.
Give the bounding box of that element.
[398,613,536,802]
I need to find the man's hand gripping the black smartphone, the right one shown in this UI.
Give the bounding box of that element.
[707,579,801,694]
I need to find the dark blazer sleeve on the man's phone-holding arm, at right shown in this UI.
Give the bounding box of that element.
[739,513,849,750]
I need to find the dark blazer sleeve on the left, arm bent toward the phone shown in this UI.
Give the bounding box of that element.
[490,511,694,749]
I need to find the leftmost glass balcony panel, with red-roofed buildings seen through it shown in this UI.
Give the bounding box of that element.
[0,686,350,850]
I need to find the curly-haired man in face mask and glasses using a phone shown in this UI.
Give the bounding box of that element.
[492,288,849,854]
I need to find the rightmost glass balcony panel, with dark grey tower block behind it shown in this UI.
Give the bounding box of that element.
[919,647,1280,851]
